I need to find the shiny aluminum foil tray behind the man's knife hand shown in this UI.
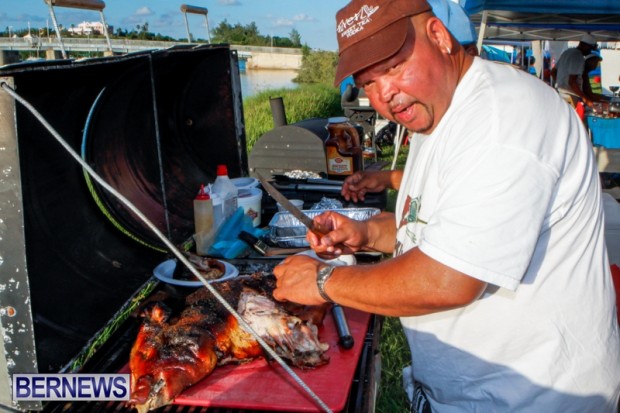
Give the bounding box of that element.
[269,208,381,248]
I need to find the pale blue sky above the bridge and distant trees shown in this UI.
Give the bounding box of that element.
[0,0,347,51]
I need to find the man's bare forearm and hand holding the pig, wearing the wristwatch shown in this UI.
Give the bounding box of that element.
[274,243,486,317]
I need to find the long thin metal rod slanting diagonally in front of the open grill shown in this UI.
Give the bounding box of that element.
[0,81,332,413]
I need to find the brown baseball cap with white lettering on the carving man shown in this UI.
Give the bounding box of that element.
[334,0,431,86]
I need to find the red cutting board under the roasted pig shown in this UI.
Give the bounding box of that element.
[163,308,370,412]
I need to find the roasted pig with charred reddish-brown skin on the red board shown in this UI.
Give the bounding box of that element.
[129,274,329,413]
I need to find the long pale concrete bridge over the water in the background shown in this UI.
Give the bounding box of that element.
[0,36,302,70]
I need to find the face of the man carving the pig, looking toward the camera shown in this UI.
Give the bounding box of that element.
[355,15,458,133]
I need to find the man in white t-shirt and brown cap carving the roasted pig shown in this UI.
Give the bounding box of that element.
[274,0,620,413]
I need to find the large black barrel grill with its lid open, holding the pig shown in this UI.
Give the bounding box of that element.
[0,45,377,412]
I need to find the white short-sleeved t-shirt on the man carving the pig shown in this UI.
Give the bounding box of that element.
[396,58,620,413]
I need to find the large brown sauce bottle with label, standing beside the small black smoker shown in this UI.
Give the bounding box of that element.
[324,117,364,180]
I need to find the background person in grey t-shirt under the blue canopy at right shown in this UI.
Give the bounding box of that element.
[551,34,598,107]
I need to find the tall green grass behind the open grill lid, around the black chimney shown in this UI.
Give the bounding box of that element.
[243,84,343,153]
